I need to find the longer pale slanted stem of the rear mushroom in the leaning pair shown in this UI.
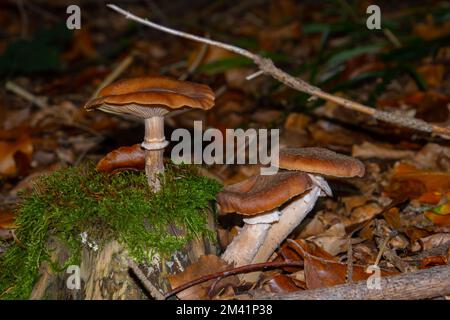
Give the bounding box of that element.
[243,186,322,282]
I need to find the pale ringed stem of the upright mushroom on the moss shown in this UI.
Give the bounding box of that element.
[141,116,168,192]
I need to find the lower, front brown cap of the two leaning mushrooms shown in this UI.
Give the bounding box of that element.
[217,172,313,215]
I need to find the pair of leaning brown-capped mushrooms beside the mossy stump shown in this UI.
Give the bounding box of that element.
[217,148,365,280]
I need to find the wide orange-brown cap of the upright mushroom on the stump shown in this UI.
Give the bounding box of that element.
[84,76,214,119]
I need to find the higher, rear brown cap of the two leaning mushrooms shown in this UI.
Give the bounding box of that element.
[278,148,365,178]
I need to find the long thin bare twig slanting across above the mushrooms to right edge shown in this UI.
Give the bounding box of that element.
[107,4,450,139]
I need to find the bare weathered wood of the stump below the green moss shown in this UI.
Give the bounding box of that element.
[30,208,217,300]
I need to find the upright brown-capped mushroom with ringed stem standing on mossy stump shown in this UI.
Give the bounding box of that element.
[84,76,218,191]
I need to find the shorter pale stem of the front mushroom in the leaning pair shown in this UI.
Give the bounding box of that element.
[222,209,280,267]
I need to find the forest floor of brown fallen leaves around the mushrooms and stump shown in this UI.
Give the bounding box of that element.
[0,0,450,299]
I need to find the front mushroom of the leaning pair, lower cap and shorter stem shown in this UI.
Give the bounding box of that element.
[217,172,312,266]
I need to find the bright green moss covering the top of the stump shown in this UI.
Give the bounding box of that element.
[0,165,220,299]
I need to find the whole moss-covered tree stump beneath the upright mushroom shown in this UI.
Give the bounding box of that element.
[0,165,220,299]
